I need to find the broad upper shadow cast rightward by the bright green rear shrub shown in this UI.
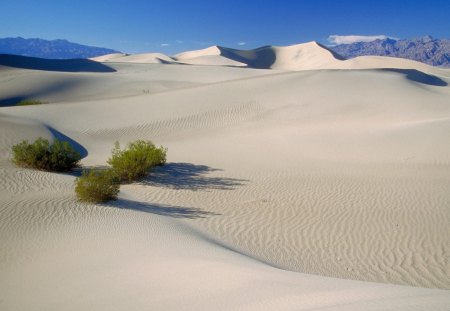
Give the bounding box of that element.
[141,163,247,191]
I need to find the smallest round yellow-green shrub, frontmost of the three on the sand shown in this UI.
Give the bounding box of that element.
[75,169,120,203]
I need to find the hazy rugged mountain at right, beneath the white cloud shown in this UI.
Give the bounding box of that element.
[330,36,450,67]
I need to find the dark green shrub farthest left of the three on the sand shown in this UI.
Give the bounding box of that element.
[12,138,81,172]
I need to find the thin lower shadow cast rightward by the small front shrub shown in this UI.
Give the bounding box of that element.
[107,199,221,219]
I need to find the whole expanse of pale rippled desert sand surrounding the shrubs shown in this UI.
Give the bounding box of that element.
[0,42,450,310]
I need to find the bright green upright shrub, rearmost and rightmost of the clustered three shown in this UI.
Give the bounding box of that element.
[108,140,167,182]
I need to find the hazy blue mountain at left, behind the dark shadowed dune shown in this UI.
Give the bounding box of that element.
[0,37,118,59]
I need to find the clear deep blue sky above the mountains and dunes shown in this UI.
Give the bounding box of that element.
[0,0,450,54]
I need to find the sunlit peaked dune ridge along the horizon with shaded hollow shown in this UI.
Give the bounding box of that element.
[92,41,450,77]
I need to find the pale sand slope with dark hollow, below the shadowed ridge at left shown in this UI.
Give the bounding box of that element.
[0,63,271,106]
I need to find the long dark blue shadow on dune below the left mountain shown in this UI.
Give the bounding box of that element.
[0,54,116,72]
